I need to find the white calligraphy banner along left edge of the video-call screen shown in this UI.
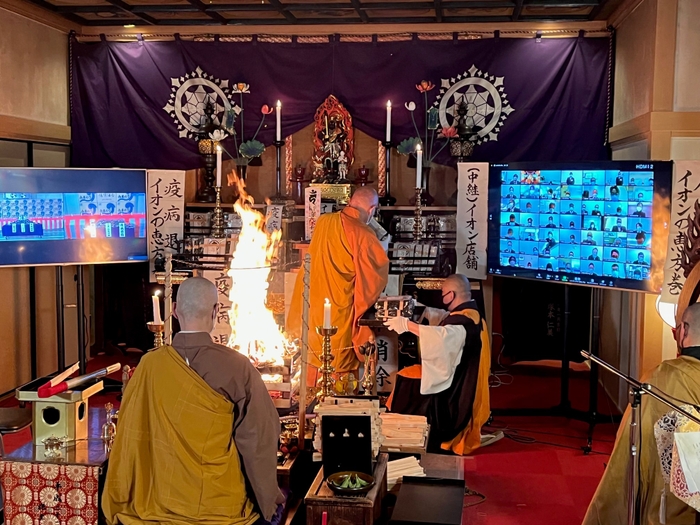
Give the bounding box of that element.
[455,162,489,279]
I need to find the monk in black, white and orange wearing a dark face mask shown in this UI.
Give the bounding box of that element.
[384,275,491,455]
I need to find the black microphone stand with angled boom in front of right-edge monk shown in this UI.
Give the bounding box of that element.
[581,350,700,525]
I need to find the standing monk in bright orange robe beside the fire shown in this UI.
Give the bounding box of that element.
[287,187,389,386]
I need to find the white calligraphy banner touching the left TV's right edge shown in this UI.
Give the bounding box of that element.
[147,170,185,282]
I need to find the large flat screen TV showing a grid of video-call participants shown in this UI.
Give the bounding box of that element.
[488,161,673,293]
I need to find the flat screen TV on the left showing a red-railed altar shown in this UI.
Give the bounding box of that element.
[0,168,148,266]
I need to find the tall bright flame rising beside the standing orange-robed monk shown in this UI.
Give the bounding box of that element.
[228,174,289,366]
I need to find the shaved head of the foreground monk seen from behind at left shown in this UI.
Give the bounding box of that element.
[175,277,219,333]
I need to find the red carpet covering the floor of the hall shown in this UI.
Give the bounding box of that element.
[0,354,617,525]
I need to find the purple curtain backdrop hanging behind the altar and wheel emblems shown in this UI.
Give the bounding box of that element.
[71,37,609,169]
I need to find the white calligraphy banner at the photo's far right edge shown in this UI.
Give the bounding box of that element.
[661,160,700,304]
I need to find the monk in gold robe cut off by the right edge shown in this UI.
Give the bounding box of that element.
[583,303,700,525]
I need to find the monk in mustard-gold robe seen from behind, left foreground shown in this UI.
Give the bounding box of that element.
[102,278,283,525]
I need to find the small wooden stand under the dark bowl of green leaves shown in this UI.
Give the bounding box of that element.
[304,454,388,525]
